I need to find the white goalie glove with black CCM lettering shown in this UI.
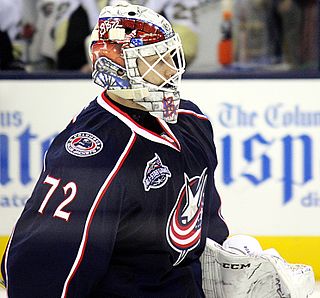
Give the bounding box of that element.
[200,236,315,298]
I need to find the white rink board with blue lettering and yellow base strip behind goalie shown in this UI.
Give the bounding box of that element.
[0,79,320,278]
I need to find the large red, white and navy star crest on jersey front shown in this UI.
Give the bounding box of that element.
[166,168,207,266]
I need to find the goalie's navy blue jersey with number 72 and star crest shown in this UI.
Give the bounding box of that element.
[2,94,228,298]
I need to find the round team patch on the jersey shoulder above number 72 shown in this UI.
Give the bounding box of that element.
[65,132,103,157]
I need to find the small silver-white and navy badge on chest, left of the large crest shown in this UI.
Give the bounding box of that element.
[143,153,171,191]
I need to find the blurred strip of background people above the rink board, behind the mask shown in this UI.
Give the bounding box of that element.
[0,0,320,73]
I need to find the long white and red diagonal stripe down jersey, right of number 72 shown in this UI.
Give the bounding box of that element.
[61,133,137,298]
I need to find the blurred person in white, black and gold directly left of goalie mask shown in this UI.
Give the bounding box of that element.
[24,0,99,70]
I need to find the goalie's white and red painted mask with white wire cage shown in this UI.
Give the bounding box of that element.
[90,2,185,123]
